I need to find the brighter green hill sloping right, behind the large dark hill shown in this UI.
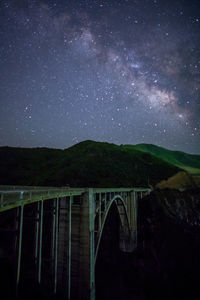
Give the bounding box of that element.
[123,144,200,174]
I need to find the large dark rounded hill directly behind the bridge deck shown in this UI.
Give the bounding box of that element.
[0,141,180,187]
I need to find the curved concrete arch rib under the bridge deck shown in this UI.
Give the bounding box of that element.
[94,195,130,264]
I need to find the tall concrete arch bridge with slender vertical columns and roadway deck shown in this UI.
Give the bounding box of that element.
[0,186,150,300]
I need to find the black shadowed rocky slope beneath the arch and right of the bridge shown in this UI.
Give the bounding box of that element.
[97,189,200,300]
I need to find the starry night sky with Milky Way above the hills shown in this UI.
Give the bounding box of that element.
[0,0,200,153]
